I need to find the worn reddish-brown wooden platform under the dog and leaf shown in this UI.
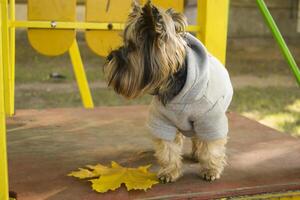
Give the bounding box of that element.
[8,106,300,200]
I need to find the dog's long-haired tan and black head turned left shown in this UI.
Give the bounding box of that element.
[104,1,187,98]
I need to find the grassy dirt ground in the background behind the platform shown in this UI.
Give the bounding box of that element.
[16,31,300,135]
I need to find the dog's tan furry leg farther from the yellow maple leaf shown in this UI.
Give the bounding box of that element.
[193,138,227,181]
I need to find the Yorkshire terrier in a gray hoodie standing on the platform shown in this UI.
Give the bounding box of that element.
[104,1,233,183]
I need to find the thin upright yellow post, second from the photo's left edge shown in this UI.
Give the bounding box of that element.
[9,0,16,115]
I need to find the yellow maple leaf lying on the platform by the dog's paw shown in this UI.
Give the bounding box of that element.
[69,162,159,193]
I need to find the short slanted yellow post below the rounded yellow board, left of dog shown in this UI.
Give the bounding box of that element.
[69,39,94,108]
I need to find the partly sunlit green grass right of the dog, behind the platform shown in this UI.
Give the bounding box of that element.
[230,87,300,136]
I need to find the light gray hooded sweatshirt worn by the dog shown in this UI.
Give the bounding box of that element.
[148,34,233,141]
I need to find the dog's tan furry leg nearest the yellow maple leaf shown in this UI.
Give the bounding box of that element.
[154,133,184,183]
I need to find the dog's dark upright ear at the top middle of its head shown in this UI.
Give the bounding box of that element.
[142,0,166,36]
